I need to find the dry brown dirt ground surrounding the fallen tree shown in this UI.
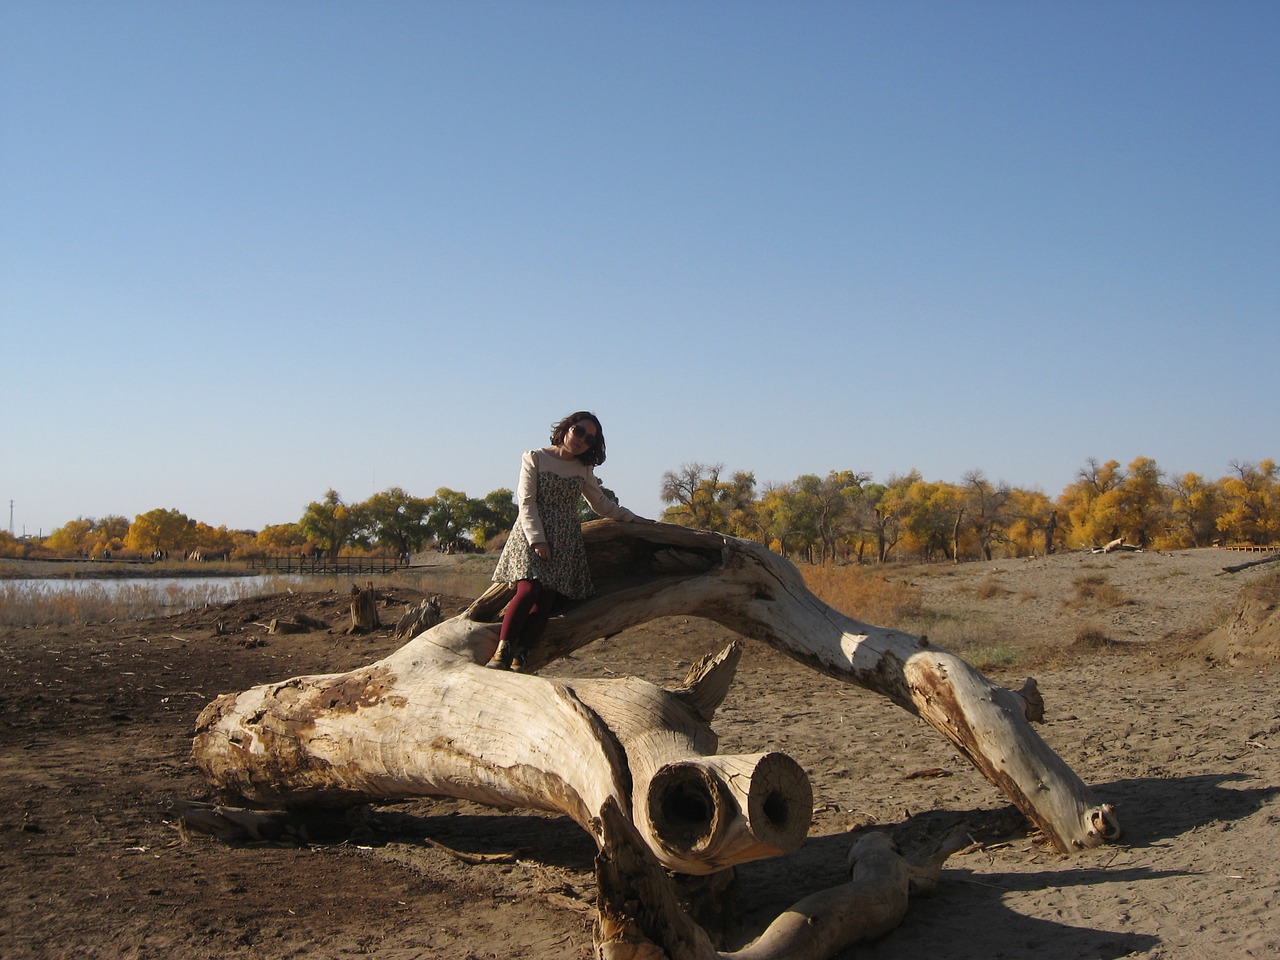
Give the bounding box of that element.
[0,550,1280,960]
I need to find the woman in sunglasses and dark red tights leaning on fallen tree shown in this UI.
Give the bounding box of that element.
[488,411,652,671]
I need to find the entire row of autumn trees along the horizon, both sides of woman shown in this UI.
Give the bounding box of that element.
[0,457,1280,563]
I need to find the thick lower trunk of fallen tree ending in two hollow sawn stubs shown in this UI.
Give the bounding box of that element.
[193,640,813,874]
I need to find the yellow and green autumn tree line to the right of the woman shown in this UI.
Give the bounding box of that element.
[662,457,1280,562]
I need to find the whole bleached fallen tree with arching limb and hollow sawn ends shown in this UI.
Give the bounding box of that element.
[193,521,1119,957]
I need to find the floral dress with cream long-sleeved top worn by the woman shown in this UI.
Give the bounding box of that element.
[493,451,635,600]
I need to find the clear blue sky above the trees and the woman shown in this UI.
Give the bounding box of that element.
[0,0,1280,534]
